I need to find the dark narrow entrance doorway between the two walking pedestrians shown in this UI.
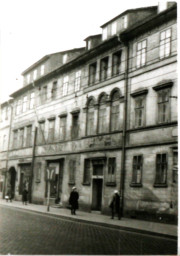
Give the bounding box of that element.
[92,179,103,211]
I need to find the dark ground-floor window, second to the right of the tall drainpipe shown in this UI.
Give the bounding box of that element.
[154,154,167,186]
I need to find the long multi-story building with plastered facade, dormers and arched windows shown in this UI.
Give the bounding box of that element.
[0,3,177,222]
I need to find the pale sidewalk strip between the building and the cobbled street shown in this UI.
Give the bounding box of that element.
[0,199,177,237]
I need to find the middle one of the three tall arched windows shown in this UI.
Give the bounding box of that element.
[98,95,106,133]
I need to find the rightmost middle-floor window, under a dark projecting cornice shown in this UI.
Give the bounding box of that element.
[157,89,170,123]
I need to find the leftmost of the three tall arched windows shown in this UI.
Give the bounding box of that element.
[86,99,94,135]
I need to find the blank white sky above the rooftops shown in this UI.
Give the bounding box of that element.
[0,0,158,103]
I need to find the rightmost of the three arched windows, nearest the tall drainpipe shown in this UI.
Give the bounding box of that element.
[111,91,119,132]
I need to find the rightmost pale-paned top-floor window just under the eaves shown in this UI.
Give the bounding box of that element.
[159,29,171,59]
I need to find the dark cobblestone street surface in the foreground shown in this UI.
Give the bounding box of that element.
[0,206,177,255]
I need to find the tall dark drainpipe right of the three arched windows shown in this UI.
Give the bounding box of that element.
[120,40,129,217]
